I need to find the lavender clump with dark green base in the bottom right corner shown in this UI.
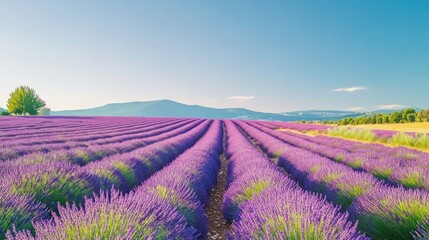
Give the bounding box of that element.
[349,187,429,239]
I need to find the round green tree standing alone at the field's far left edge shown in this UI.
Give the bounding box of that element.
[7,86,46,115]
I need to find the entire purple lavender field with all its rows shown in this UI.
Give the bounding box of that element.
[0,117,429,240]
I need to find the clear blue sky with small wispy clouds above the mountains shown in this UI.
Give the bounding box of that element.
[0,0,429,112]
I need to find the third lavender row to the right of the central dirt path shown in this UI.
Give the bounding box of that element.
[249,123,429,190]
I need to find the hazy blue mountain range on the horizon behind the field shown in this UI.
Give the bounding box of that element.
[51,100,363,121]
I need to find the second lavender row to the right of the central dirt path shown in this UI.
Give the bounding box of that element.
[237,122,429,239]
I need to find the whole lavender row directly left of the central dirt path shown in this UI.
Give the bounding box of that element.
[8,121,222,239]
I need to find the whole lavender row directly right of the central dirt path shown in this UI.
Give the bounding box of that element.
[223,121,366,239]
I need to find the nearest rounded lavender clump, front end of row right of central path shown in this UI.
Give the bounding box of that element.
[228,188,368,239]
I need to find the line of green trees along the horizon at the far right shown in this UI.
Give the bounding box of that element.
[337,108,429,125]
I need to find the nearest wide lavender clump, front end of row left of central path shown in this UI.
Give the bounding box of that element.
[7,190,196,240]
